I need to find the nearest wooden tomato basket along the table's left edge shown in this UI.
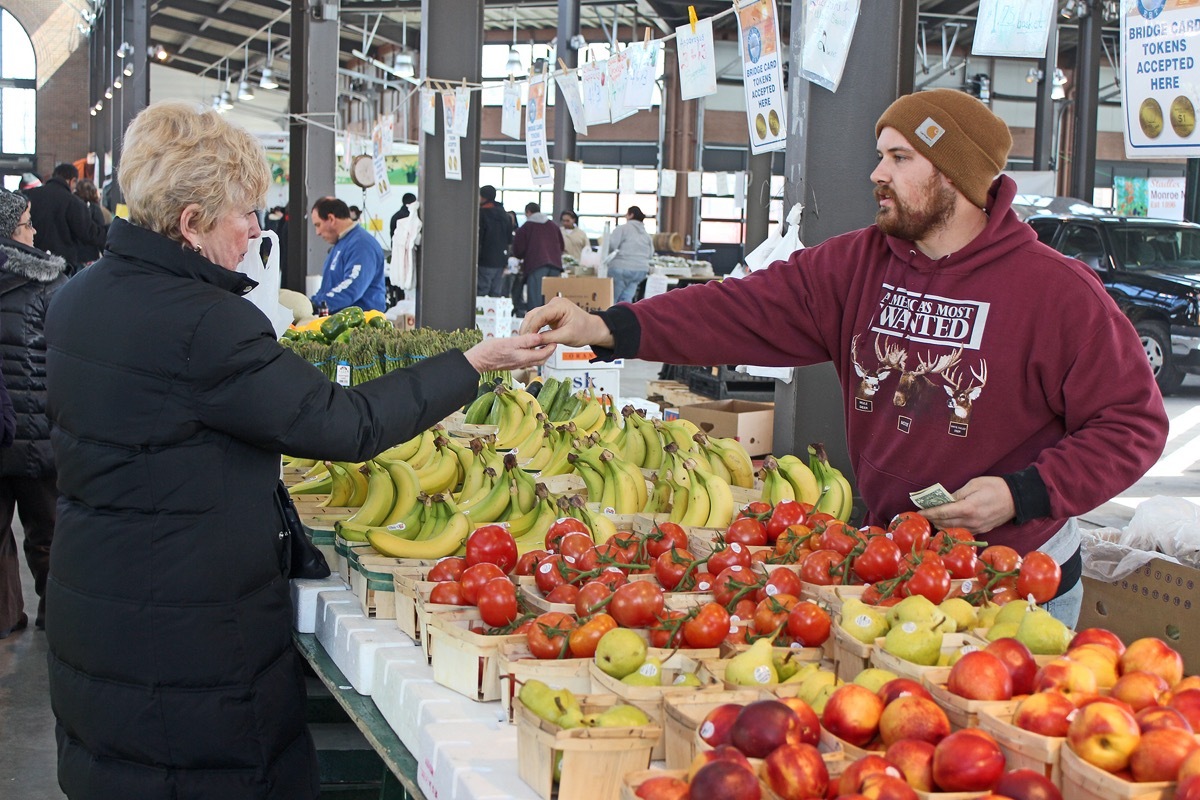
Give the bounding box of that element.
[428,608,526,702]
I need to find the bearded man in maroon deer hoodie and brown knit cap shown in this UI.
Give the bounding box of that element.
[522,89,1168,625]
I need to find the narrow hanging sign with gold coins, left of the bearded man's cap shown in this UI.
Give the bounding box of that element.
[738,0,792,155]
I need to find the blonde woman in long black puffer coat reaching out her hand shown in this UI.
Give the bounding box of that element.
[46,102,553,800]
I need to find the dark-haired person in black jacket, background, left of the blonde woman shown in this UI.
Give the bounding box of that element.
[25,163,108,272]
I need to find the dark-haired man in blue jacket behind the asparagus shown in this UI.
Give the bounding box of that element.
[311,197,388,313]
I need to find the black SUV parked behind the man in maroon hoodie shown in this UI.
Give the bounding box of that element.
[1026,215,1200,395]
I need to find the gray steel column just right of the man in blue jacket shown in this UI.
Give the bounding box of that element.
[416,0,482,330]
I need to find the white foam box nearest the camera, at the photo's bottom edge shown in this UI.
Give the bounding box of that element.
[416,722,538,800]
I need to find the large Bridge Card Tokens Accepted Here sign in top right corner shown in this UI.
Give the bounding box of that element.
[1121,0,1200,158]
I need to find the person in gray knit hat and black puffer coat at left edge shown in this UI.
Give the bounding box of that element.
[0,190,67,639]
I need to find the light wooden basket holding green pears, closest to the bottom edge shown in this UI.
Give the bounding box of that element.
[512,694,662,800]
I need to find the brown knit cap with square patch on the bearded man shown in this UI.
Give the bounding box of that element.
[875,89,1013,209]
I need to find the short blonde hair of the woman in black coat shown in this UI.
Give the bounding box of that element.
[116,101,271,243]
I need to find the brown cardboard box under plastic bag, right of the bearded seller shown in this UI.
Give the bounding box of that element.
[1075,558,1200,675]
